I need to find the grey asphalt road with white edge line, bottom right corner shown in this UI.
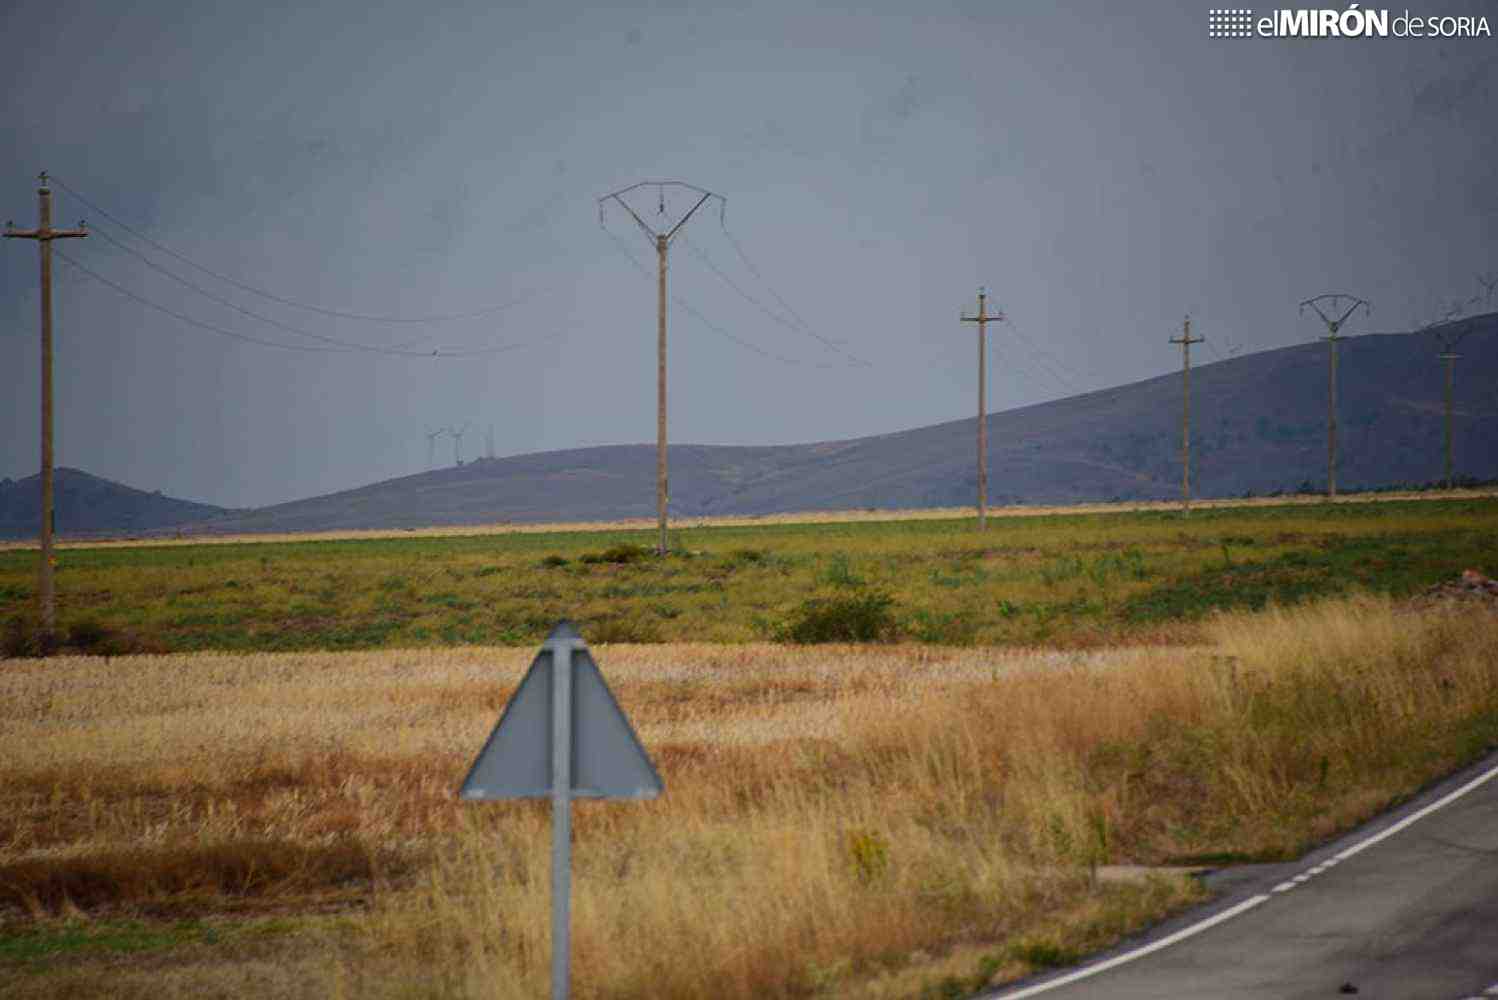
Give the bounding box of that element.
[984,754,1498,1000]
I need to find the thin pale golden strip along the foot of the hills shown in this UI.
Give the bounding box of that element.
[0,488,1498,552]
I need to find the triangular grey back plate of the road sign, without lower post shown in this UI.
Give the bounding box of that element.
[458,621,665,799]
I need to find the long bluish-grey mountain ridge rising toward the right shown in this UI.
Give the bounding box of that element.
[0,314,1498,534]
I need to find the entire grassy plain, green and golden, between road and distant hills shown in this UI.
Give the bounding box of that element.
[0,497,1498,1000]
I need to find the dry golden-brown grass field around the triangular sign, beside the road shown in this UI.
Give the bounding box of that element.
[0,596,1498,1000]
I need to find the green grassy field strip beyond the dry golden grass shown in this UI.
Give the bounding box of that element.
[0,497,1498,653]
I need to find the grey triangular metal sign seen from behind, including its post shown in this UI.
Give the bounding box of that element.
[458,621,665,1000]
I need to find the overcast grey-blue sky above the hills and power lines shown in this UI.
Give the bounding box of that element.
[0,0,1498,506]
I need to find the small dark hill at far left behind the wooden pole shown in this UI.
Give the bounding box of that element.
[0,466,234,537]
